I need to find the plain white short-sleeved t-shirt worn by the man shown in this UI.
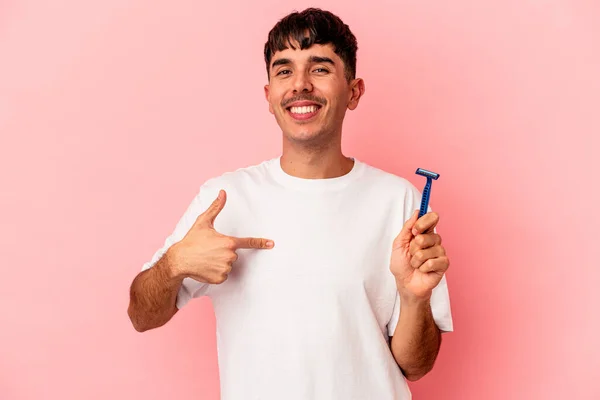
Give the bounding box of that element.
[143,157,453,400]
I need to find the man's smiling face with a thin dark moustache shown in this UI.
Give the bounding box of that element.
[265,43,364,143]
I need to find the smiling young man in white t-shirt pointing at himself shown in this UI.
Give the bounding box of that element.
[128,9,452,400]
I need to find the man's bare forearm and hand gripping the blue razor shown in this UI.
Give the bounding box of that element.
[390,210,449,381]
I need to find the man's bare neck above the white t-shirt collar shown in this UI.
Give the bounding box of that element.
[281,141,354,179]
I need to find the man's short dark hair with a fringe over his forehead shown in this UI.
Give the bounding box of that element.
[265,8,358,82]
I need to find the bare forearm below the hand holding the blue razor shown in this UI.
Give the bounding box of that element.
[391,299,441,381]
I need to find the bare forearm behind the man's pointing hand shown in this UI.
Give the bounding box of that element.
[127,251,183,332]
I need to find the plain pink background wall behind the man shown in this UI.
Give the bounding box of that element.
[0,0,600,400]
